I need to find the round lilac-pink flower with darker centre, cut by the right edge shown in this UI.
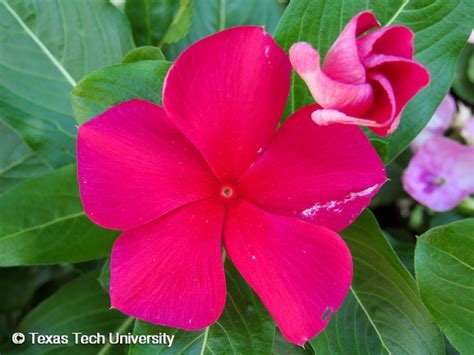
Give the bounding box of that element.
[402,137,474,212]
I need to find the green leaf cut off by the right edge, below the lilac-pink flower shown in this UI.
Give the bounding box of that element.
[415,218,474,354]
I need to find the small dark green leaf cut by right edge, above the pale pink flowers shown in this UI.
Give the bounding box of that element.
[453,43,474,105]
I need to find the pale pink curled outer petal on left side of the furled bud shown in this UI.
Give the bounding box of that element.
[290,42,373,116]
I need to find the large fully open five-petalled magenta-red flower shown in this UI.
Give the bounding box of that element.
[77,27,385,344]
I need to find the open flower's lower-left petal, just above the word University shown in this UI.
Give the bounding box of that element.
[110,199,226,330]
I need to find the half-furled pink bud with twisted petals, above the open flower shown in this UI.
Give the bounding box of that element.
[290,11,429,136]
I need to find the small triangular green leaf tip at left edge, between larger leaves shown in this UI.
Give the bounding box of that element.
[0,121,51,195]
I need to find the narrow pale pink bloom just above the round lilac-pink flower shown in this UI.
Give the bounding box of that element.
[411,94,456,151]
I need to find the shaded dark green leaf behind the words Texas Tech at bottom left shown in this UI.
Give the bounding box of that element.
[4,272,134,355]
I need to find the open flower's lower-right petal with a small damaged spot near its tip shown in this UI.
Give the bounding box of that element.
[224,200,352,345]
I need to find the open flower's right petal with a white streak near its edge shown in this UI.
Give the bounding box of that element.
[238,105,386,231]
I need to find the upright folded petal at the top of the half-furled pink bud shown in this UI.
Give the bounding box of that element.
[323,11,380,84]
